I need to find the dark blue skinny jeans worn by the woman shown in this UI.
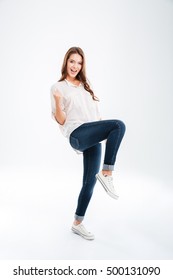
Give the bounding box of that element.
[70,120,125,221]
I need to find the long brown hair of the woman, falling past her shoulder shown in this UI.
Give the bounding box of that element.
[59,47,98,101]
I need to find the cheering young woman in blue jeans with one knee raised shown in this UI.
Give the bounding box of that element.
[51,47,125,240]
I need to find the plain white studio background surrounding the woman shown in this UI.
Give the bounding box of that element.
[0,0,173,260]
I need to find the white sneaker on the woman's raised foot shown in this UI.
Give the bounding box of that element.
[96,171,119,199]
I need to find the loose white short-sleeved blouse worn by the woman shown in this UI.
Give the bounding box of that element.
[51,80,101,138]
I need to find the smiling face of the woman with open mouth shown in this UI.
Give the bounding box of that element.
[67,53,82,79]
